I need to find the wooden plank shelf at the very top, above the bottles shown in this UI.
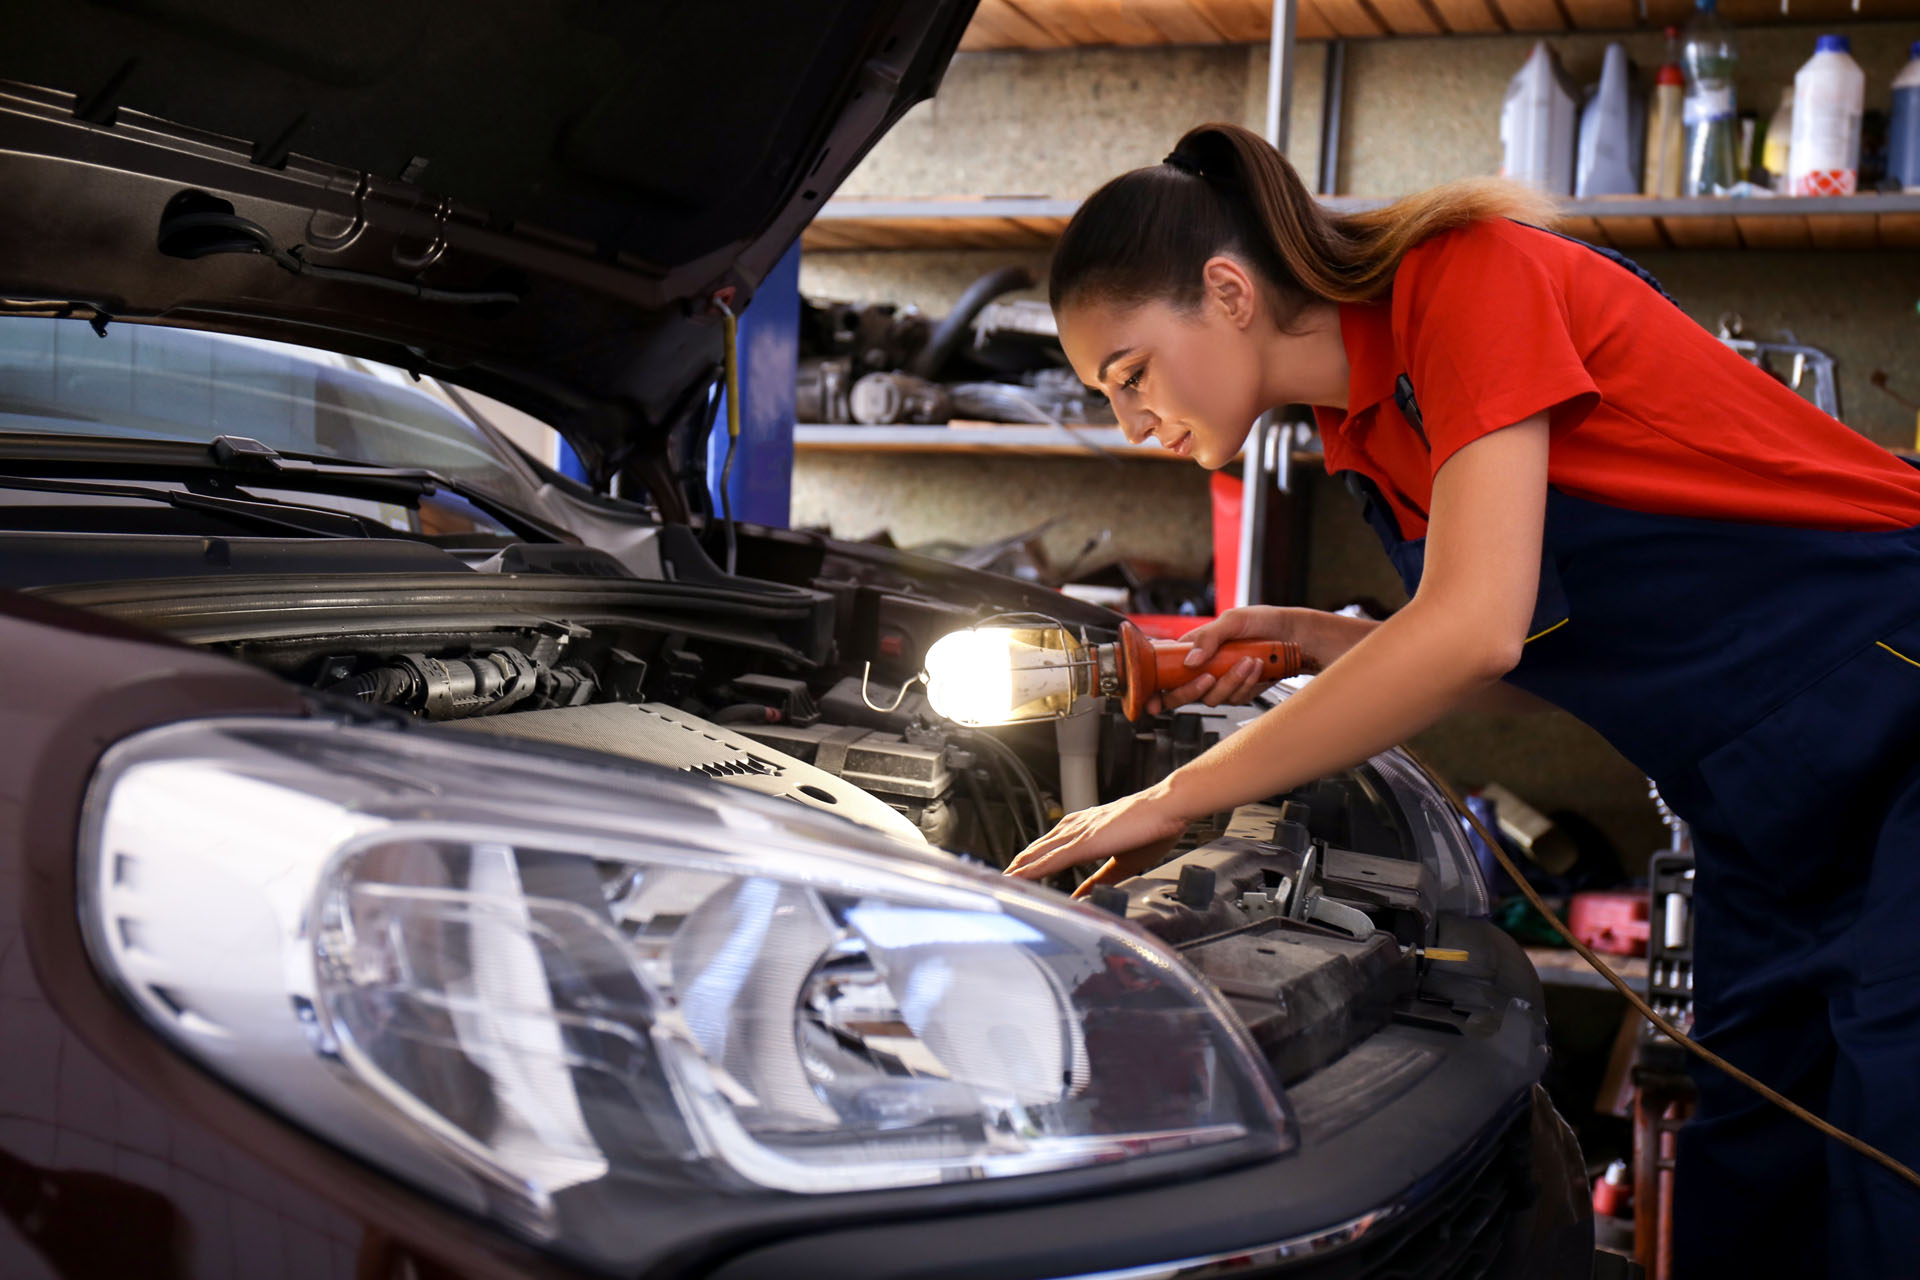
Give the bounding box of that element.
[960,0,1920,50]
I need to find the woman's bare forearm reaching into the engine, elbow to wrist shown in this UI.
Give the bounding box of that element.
[1156,601,1515,816]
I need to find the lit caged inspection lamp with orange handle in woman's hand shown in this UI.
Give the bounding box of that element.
[924,614,1306,725]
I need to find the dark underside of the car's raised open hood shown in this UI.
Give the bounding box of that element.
[0,0,975,476]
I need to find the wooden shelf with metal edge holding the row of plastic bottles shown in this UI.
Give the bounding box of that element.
[801,194,1920,251]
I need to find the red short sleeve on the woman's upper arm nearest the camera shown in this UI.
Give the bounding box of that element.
[1394,223,1603,472]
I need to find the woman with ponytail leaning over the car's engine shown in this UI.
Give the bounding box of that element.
[1010,125,1920,1276]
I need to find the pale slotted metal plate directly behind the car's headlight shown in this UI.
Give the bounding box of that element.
[441,702,922,842]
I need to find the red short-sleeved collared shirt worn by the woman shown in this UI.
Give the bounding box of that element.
[1315,221,1920,537]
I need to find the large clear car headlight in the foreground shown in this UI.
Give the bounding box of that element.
[81,720,1290,1266]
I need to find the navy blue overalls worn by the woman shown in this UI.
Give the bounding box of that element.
[1346,239,1920,1280]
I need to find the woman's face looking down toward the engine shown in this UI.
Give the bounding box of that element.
[1060,268,1273,470]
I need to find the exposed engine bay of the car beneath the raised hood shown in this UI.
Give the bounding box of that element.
[18,514,1492,1082]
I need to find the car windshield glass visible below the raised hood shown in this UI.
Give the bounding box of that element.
[0,317,549,509]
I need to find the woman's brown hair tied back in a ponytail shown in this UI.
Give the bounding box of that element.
[1048,125,1555,328]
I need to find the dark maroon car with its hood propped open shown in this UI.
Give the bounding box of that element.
[0,0,1592,1280]
